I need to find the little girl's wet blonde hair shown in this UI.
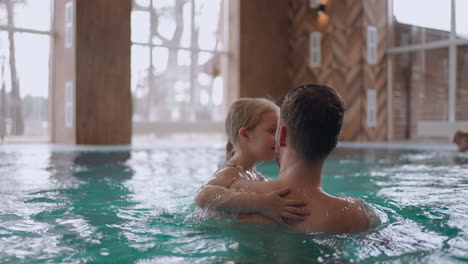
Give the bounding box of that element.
[224,98,279,160]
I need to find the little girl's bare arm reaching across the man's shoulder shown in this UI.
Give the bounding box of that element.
[195,168,308,224]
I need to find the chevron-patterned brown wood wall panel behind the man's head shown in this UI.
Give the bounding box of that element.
[288,0,387,141]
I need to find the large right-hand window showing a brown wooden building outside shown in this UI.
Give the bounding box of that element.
[388,0,468,140]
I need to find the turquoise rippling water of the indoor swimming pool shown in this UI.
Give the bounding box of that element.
[0,144,468,263]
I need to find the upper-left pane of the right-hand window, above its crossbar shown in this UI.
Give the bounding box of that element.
[393,0,451,46]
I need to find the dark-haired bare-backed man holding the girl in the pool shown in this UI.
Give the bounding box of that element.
[197,84,379,233]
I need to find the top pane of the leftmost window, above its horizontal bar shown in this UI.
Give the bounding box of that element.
[0,0,52,31]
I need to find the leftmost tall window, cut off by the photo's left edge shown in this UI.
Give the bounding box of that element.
[0,0,52,141]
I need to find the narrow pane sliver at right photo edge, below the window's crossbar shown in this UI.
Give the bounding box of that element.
[455,45,468,121]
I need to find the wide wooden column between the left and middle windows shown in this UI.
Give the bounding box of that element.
[52,0,132,145]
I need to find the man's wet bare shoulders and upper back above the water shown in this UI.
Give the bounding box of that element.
[229,179,378,233]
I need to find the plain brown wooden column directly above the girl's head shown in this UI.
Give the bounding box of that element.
[231,0,290,101]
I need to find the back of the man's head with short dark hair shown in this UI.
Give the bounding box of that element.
[280,84,344,162]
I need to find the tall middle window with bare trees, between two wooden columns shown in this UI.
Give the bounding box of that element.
[131,0,228,139]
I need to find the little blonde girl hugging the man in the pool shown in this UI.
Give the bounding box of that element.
[195,98,307,224]
